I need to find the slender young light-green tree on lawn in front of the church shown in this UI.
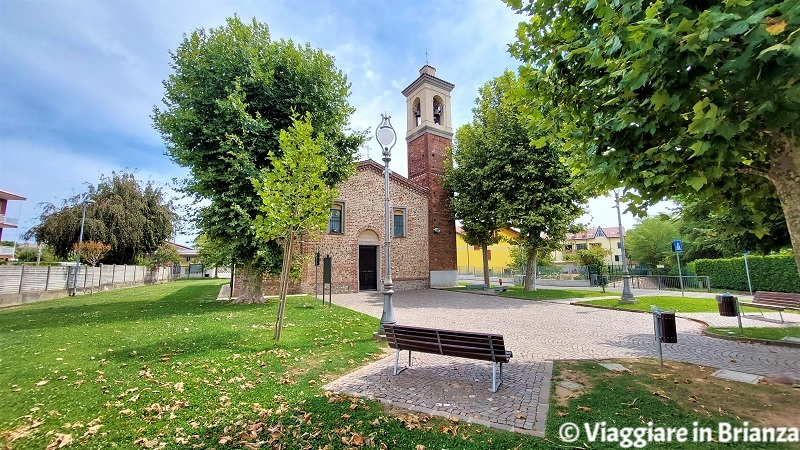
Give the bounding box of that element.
[253,113,338,340]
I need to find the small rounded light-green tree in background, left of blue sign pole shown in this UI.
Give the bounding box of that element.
[625,216,680,267]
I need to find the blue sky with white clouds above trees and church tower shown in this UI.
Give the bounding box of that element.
[0,0,665,244]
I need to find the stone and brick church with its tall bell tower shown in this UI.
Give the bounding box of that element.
[264,65,458,294]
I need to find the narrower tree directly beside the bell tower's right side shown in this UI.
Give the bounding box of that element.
[444,122,502,286]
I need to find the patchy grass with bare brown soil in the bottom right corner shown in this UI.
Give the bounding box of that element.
[547,360,800,449]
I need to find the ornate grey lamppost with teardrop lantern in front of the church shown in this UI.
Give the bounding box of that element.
[375,114,397,338]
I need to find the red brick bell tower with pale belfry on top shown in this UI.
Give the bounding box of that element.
[403,64,458,287]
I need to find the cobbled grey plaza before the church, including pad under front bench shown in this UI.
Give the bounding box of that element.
[326,290,800,436]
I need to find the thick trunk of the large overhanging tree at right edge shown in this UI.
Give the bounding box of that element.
[768,134,800,275]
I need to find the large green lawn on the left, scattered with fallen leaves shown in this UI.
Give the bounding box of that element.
[0,280,548,449]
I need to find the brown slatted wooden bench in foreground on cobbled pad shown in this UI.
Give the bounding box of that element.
[383,323,511,392]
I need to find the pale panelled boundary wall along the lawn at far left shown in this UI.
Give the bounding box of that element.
[0,264,176,295]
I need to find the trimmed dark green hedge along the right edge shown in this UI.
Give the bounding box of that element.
[694,255,800,293]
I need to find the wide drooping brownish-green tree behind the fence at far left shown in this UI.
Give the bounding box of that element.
[25,172,178,264]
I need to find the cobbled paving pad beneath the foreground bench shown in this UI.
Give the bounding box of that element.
[323,351,553,437]
